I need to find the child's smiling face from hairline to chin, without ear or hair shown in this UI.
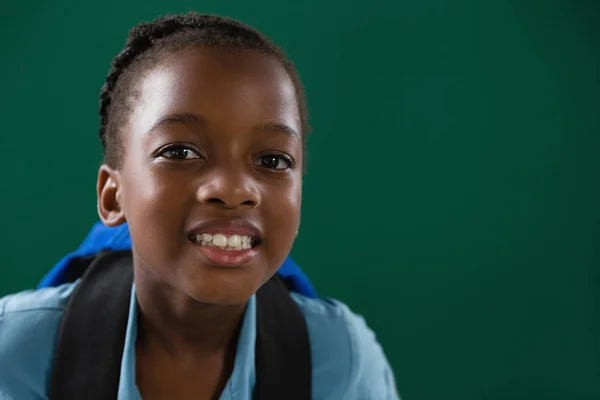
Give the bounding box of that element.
[103,48,303,304]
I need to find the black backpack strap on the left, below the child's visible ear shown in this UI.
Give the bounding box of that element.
[48,251,133,400]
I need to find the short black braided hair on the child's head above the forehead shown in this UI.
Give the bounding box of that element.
[99,12,309,168]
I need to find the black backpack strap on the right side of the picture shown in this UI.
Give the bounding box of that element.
[254,275,312,400]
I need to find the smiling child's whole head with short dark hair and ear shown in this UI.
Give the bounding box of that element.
[97,13,308,304]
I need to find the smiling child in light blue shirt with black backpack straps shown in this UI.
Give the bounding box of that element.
[0,13,398,400]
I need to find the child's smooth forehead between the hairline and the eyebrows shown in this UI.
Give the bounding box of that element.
[129,48,301,136]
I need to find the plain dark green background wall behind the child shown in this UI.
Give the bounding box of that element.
[0,0,600,400]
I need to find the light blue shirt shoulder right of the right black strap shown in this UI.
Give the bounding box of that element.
[292,293,399,400]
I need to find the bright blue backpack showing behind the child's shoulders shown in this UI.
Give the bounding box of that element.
[38,222,317,297]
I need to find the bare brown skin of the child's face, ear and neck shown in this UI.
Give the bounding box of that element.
[97,48,302,400]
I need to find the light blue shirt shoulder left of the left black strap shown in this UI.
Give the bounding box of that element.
[0,284,75,400]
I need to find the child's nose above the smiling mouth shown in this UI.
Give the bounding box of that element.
[197,168,260,209]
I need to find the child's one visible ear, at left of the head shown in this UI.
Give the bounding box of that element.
[96,164,126,226]
